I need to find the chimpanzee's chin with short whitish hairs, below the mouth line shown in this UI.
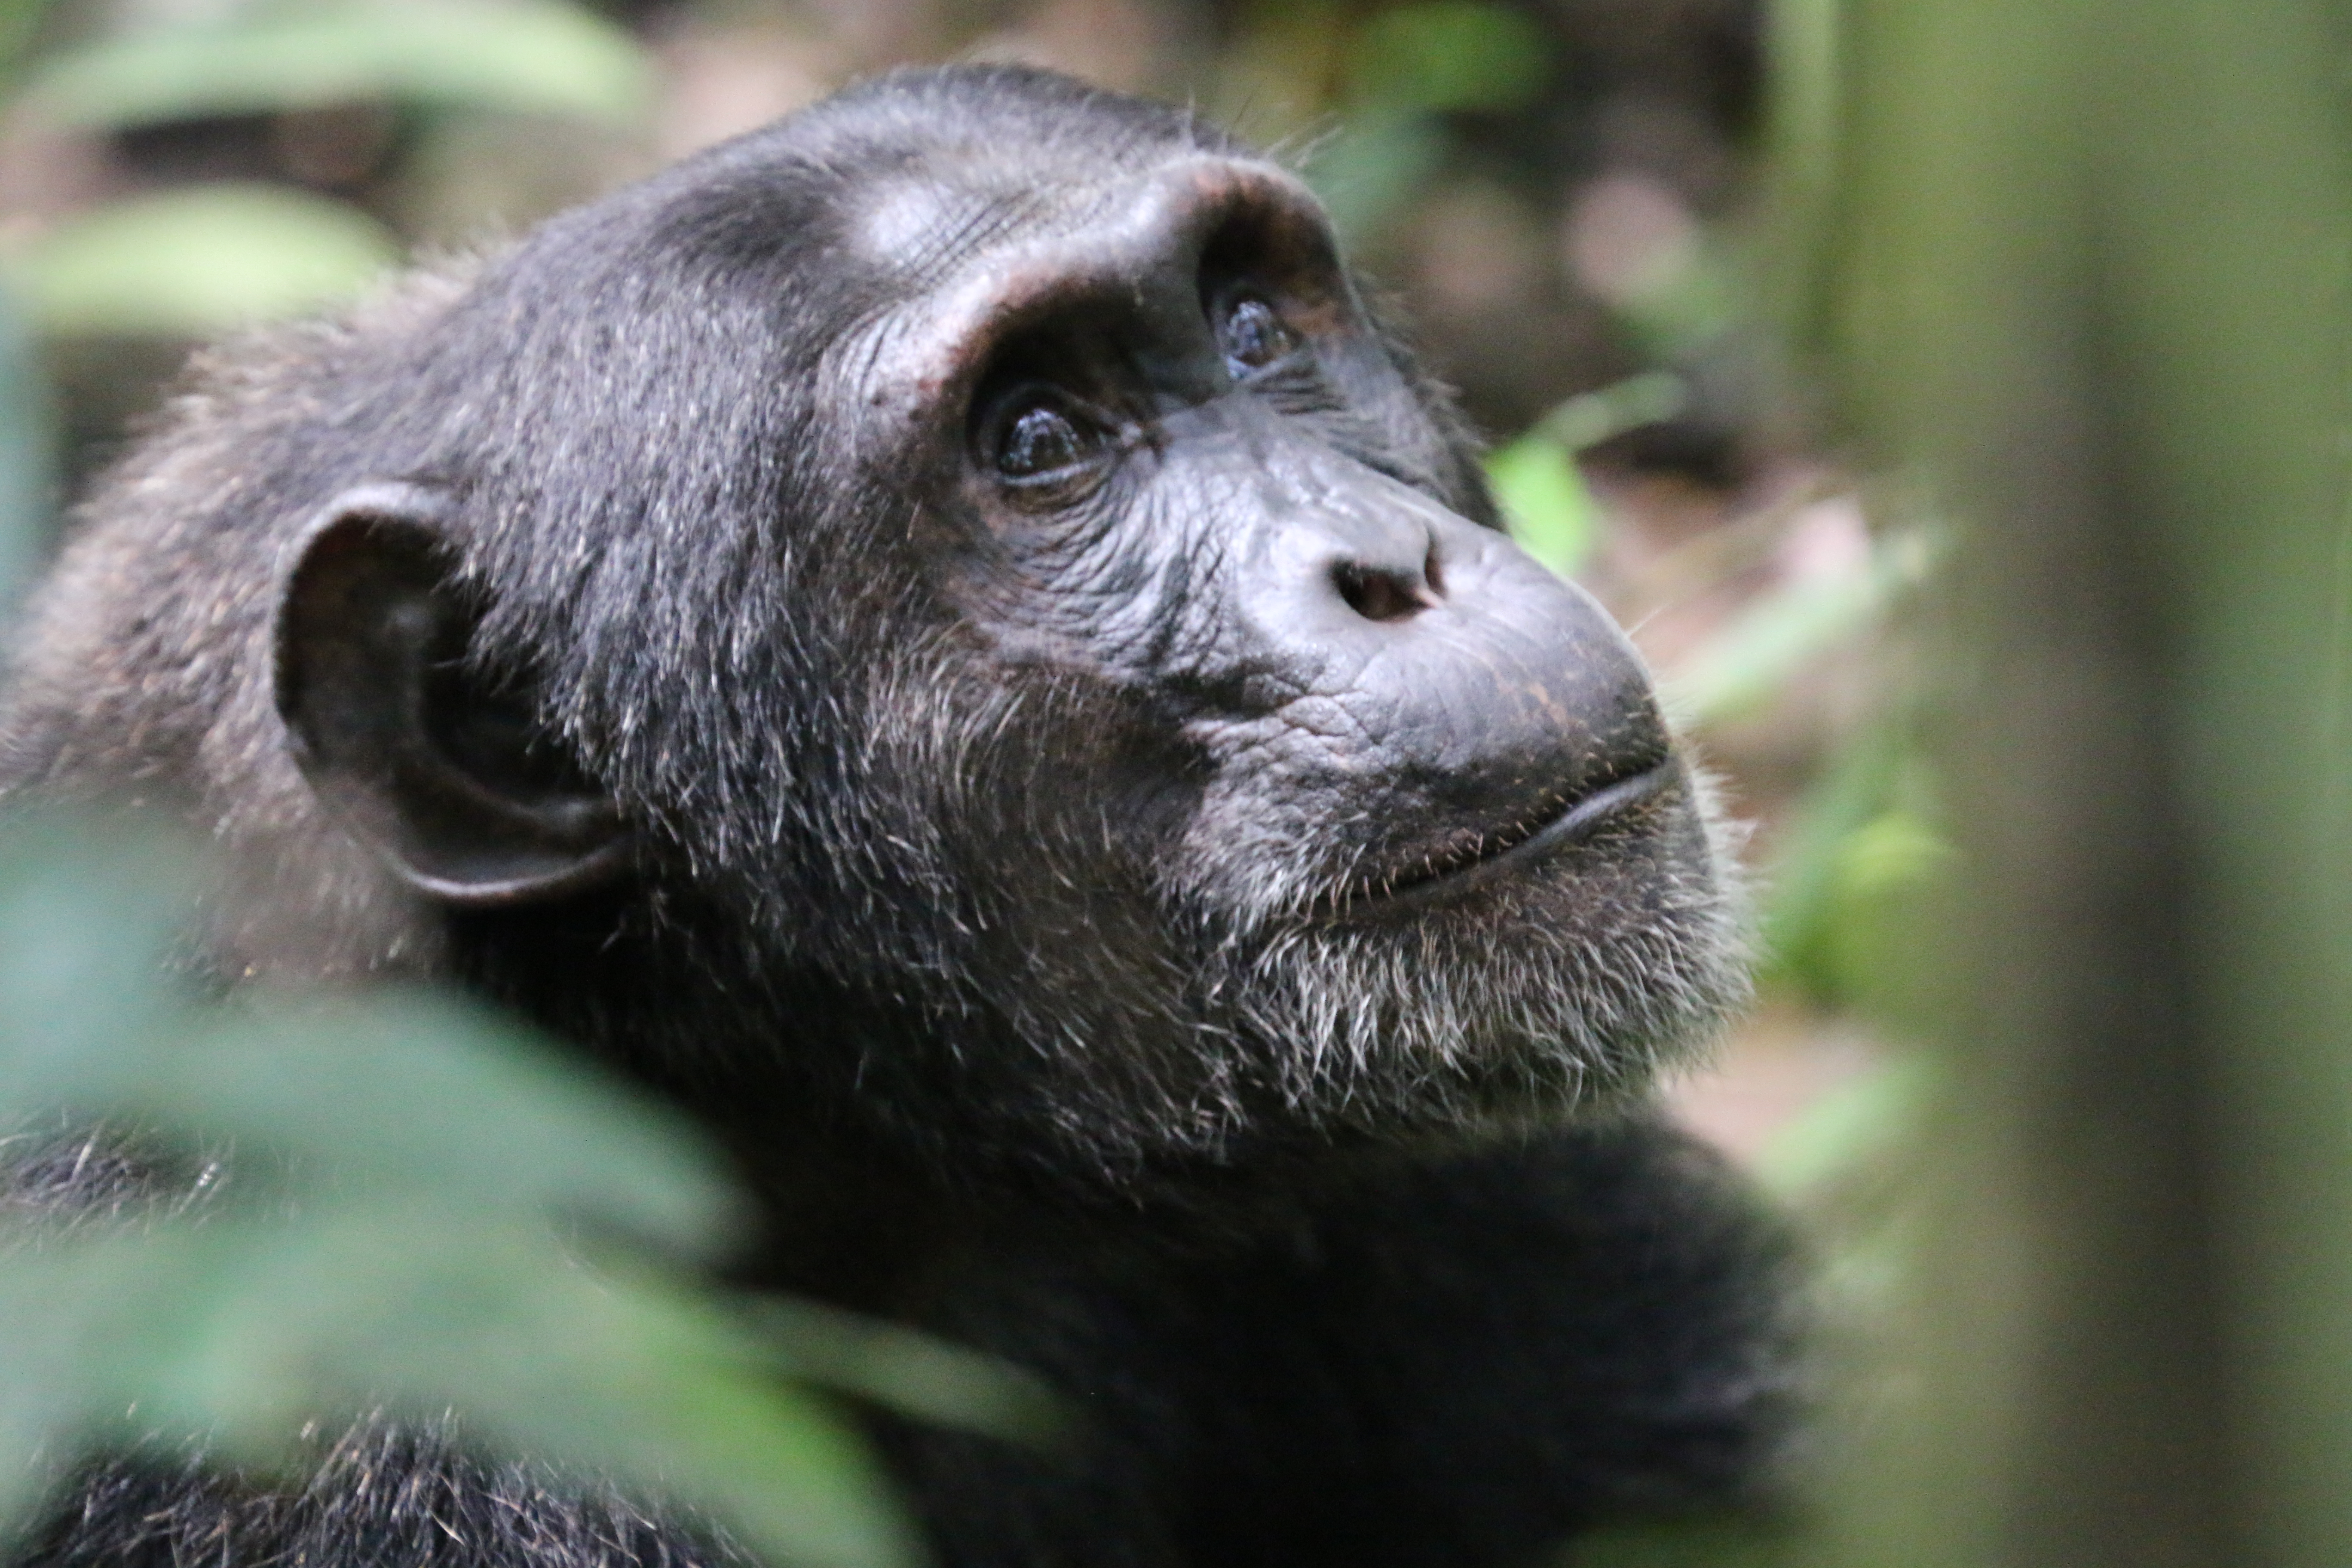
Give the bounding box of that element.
[1211,760,1752,1133]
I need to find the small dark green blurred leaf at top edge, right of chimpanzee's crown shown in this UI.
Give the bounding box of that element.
[1348,0,1550,113]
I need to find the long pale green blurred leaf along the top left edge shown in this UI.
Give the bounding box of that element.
[26,0,652,127]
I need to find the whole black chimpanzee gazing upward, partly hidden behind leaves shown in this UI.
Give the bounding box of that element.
[0,68,1799,1568]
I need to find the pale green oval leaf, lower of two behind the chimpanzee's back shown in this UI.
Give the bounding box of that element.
[16,186,400,339]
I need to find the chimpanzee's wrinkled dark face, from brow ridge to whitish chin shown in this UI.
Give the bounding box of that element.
[753,129,1743,1147]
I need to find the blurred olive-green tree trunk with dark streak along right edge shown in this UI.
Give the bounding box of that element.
[1778,0,2352,1568]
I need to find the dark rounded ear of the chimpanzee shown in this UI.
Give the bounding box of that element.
[278,484,630,907]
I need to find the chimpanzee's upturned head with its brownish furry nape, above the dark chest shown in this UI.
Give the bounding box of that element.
[9,68,1743,1171]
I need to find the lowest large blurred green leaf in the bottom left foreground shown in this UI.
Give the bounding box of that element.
[0,1201,915,1568]
